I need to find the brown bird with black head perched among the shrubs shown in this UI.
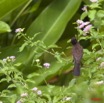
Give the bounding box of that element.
[71,37,83,76]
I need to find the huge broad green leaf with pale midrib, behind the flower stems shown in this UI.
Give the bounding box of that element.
[18,0,81,64]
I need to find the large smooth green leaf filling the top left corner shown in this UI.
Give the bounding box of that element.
[0,0,28,19]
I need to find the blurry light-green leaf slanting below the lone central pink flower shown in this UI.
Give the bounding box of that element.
[27,60,66,85]
